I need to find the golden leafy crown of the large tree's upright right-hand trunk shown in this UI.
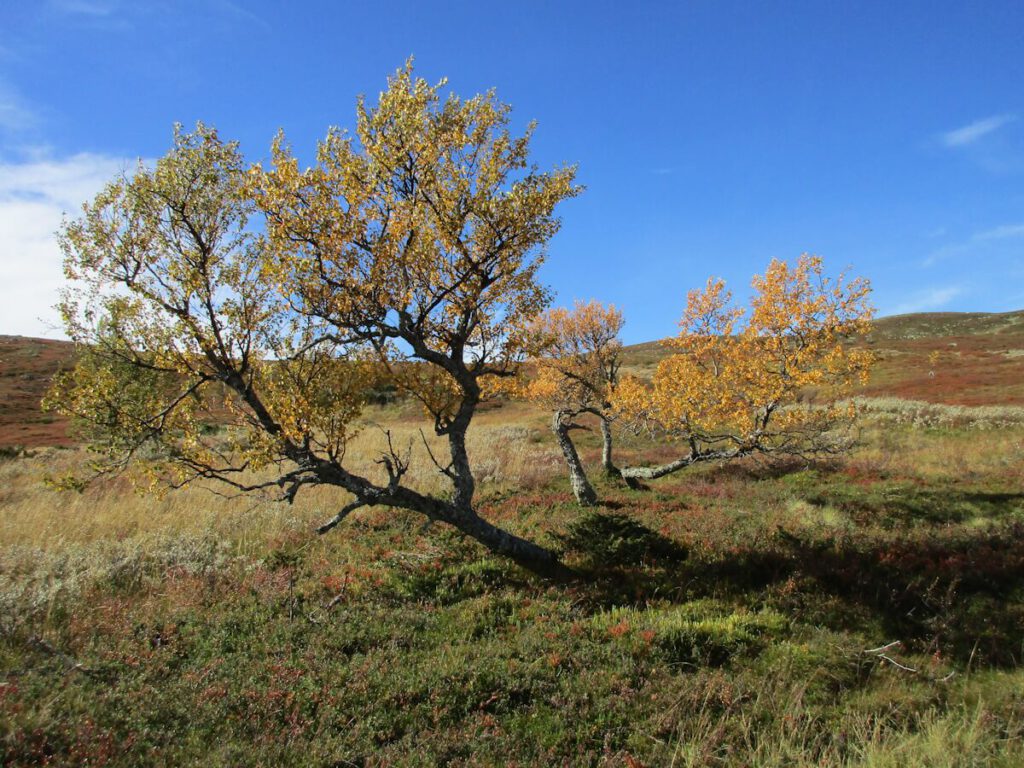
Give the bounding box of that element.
[247,62,580,416]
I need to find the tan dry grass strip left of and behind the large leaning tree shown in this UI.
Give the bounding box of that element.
[0,414,561,554]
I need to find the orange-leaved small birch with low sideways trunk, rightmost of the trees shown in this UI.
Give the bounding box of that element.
[614,259,873,483]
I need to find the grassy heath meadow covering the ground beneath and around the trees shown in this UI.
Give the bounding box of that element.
[0,319,1024,768]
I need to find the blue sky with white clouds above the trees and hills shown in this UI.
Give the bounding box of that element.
[0,0,1024,342]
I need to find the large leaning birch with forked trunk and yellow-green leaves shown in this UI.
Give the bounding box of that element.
[50,65,580,569]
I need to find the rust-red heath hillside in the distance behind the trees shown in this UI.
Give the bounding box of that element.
[0,310,1024,447]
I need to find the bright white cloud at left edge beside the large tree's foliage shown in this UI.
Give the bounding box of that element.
[0,154,129,338]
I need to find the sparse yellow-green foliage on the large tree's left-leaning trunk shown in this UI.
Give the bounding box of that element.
[50,124,335,483]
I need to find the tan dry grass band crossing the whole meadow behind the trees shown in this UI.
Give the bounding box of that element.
[0,398,1024,555]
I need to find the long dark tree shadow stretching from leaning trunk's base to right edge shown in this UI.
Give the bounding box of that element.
[571,515,1024,667]
